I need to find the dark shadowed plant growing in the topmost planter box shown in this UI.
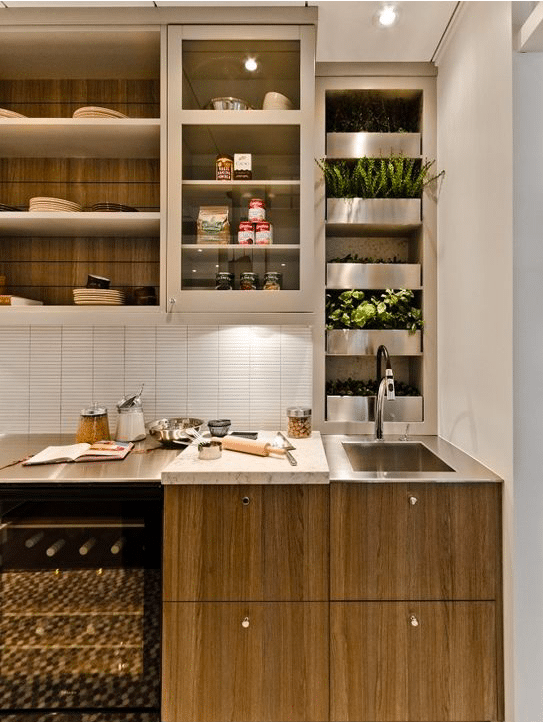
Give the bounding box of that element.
[326,90,421,133]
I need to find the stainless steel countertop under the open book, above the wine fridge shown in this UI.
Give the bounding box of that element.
[0,434,182,484]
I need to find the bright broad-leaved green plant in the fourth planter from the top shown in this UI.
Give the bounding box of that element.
[326,288,423,333]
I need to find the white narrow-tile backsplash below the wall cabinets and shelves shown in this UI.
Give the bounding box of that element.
[0,325,312,433]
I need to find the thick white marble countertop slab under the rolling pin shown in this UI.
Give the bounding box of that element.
[162,431,329,484]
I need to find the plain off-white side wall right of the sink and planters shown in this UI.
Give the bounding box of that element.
[437,2,516,722]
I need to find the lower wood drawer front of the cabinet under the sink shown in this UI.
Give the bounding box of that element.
[330,602,498,722]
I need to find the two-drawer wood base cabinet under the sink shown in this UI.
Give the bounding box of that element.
[330,482,503,722]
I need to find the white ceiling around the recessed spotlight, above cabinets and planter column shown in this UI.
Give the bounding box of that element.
[0,0,458,62]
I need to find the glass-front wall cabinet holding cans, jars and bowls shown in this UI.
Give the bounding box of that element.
[168,26,314,312]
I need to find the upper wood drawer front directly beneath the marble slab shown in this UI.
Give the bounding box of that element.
[164,485,328,601]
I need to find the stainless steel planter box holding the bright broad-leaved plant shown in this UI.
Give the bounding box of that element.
[326,328,422,356]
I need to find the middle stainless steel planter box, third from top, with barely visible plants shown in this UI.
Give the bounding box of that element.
[326,263,421,288]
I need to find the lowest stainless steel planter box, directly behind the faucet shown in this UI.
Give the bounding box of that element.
[326,396,423,421]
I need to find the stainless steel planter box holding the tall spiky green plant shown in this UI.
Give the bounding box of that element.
[326,198,421,225]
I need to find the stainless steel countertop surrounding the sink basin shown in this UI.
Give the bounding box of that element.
[322,434,501,482]
